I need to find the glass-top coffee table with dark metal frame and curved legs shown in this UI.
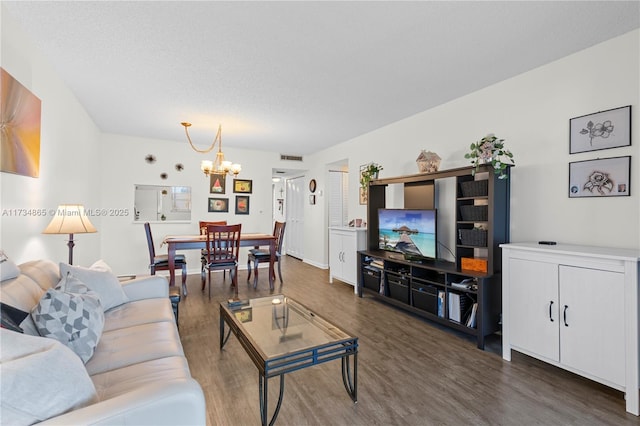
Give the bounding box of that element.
[220,295,358,425]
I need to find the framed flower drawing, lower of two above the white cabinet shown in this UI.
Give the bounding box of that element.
[569,156,631,198]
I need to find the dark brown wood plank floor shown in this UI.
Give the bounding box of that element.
[180,257,640,426]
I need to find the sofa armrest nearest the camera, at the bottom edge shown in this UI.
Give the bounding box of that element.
[40,379,207,426]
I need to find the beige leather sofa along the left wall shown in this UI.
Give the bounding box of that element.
[0,260,206,425]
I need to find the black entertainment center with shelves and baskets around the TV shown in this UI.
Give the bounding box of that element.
[357,166,510,349]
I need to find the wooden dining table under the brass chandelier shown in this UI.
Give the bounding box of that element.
[162,232,276,294]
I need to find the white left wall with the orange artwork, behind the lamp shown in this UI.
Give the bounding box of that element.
[0,8,101,264]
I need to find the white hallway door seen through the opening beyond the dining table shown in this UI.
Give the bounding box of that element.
[285,177,305,259]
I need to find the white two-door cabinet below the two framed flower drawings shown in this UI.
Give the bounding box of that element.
[501,243,640,415]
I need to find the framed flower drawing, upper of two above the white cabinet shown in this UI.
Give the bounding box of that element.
[569,105,631,154]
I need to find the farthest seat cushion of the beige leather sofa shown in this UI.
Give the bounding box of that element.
[103,298,175,333]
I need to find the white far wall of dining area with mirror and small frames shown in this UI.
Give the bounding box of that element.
[100,131,300,274]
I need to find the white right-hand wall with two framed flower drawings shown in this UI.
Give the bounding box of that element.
[309,30,640,255]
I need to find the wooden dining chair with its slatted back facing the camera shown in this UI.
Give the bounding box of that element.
[202,224,242,298]
